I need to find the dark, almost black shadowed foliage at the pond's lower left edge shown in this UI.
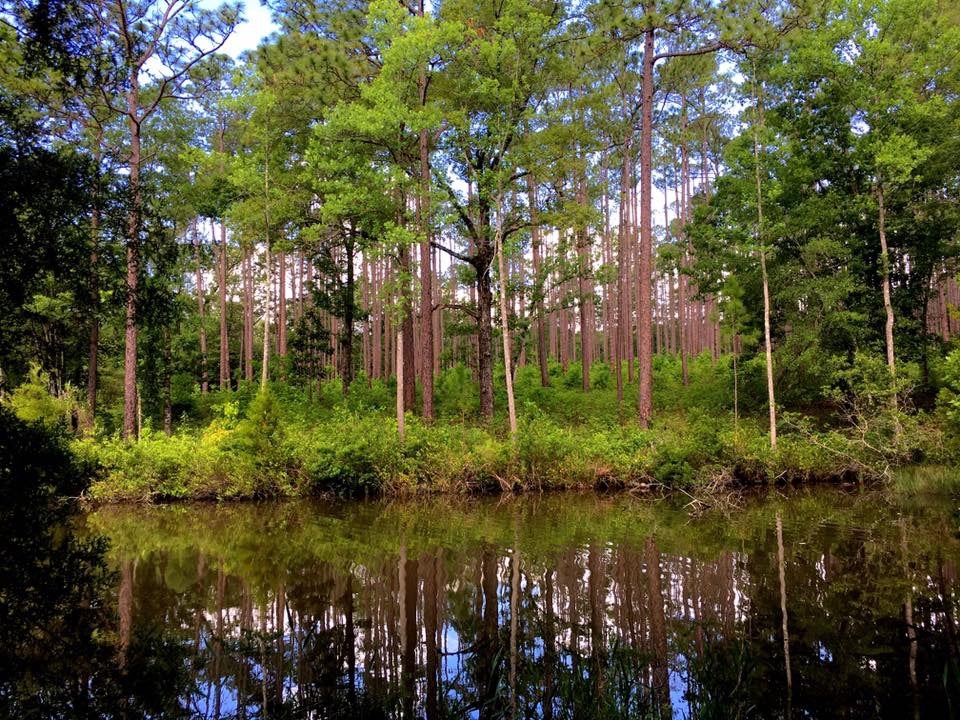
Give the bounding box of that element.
[0,407,193,718]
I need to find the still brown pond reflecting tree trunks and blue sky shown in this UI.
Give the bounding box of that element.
[1,489,960,718]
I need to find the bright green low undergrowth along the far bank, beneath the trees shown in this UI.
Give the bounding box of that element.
[22,357,958,503]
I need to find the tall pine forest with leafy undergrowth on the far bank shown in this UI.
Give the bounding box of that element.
[0,0,960,502]
